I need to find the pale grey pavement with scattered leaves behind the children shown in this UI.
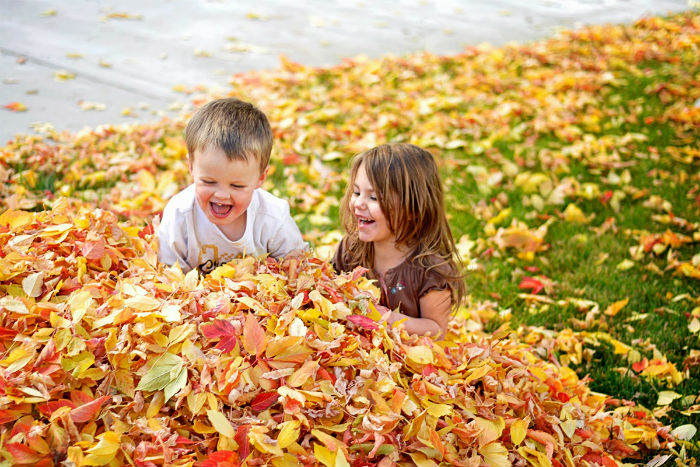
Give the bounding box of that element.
[0,0,689,144]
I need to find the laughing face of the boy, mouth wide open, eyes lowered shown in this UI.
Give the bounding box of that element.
[189,146,267,240]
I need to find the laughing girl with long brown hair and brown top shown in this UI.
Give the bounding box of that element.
[333,144,464,338]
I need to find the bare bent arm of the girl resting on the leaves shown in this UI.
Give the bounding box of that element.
[386,289,452,339]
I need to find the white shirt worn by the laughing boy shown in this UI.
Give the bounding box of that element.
[158,184,306,273]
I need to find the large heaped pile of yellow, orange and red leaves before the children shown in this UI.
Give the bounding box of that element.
[0,205,673,467]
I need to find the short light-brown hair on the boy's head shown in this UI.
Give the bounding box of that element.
[185,97,272,172]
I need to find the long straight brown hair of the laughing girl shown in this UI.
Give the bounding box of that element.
[340,143,465,307]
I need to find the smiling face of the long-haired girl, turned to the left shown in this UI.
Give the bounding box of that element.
[350,164,394,244]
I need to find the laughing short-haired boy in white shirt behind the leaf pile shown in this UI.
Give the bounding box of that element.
[158,98,305,274]
